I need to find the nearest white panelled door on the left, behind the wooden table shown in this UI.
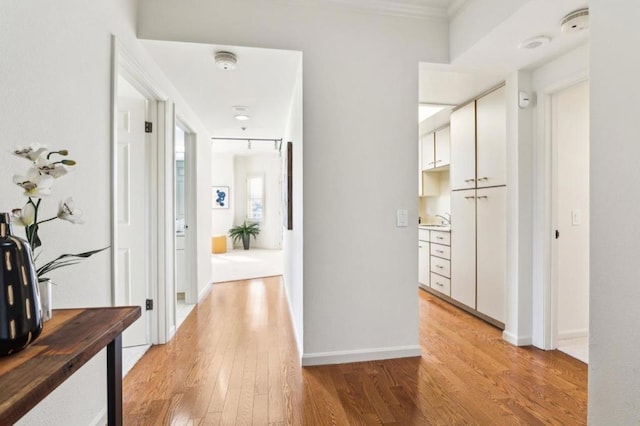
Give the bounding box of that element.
[115,91,151,346]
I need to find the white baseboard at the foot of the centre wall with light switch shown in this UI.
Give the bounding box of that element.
[302,345,422,367]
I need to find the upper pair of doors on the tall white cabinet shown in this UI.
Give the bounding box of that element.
[451,86,507,191]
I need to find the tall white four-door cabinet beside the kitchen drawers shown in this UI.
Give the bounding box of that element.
[450,86,506,324]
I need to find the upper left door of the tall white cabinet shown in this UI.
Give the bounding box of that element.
[450,102,476,189]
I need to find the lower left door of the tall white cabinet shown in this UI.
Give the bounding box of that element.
[451,190,476,309]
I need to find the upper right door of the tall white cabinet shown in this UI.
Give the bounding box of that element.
[476,86,507,188]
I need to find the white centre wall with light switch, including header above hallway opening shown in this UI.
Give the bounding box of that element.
[139,0,448,363]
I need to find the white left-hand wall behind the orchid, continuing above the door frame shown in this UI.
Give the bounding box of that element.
[0,0,211,425]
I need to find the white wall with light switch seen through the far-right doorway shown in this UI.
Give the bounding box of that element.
[551,81,589,339]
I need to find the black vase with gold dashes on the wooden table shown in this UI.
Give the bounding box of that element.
[0,213,42,356]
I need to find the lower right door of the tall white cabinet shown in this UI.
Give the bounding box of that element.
[476,186,507,323]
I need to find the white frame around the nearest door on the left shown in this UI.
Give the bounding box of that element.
[110,35,173,344]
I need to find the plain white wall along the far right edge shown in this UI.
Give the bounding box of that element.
[588,0,640,425]
